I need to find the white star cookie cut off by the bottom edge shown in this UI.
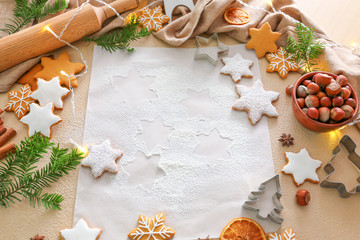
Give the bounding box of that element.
[60,218,102,240]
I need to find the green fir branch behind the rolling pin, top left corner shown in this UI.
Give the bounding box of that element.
[0,0,68,34]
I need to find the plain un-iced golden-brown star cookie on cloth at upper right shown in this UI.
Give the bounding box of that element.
[245,22,281,58]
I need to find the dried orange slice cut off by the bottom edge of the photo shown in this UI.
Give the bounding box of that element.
[220,217,267,240]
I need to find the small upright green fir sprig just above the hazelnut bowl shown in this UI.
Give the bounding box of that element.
[285,23,325,72]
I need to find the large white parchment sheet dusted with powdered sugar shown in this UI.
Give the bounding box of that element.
[74,45,274,240]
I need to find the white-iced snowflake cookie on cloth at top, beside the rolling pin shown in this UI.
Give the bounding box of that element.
[139,6,170,31]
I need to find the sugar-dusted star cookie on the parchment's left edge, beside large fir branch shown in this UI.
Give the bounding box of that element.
[81,139,123,178]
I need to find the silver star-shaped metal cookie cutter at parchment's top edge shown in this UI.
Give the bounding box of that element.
[194,33,229,66]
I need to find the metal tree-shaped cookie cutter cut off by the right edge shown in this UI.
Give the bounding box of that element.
[320,135,360,198]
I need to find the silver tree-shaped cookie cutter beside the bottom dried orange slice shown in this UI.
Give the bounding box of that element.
[243,175,284,224]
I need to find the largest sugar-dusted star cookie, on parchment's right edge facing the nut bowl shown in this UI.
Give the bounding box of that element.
[232,79,280,125]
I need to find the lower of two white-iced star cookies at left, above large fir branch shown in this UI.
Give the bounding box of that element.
[20,103,62,138]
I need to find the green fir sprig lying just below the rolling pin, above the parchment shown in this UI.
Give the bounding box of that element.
[83,17,151,53]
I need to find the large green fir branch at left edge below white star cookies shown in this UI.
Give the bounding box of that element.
[0,134,82,209]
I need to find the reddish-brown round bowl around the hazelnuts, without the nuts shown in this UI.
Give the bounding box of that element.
[292,72,359,132]
